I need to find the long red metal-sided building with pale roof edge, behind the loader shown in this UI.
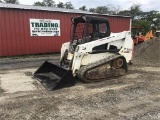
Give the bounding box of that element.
[0,3,131,56]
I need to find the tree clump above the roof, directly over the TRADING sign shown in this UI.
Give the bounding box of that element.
[33,0,56,7]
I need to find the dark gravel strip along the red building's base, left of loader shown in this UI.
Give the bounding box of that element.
[0,54,60,70]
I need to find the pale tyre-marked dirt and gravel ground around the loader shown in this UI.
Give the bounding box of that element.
[0,39,160,120]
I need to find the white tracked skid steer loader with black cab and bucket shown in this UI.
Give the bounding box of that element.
[34,15,133,90]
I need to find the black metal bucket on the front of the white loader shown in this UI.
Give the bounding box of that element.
[33,61,75,90]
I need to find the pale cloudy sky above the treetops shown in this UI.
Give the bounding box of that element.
[19,0,160,12]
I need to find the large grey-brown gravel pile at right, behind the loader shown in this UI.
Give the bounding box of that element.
[133,38,160,66]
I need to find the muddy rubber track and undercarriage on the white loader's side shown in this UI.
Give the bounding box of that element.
[77,55,127,82]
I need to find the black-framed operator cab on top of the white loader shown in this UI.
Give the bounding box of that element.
[71,15,110,51]
